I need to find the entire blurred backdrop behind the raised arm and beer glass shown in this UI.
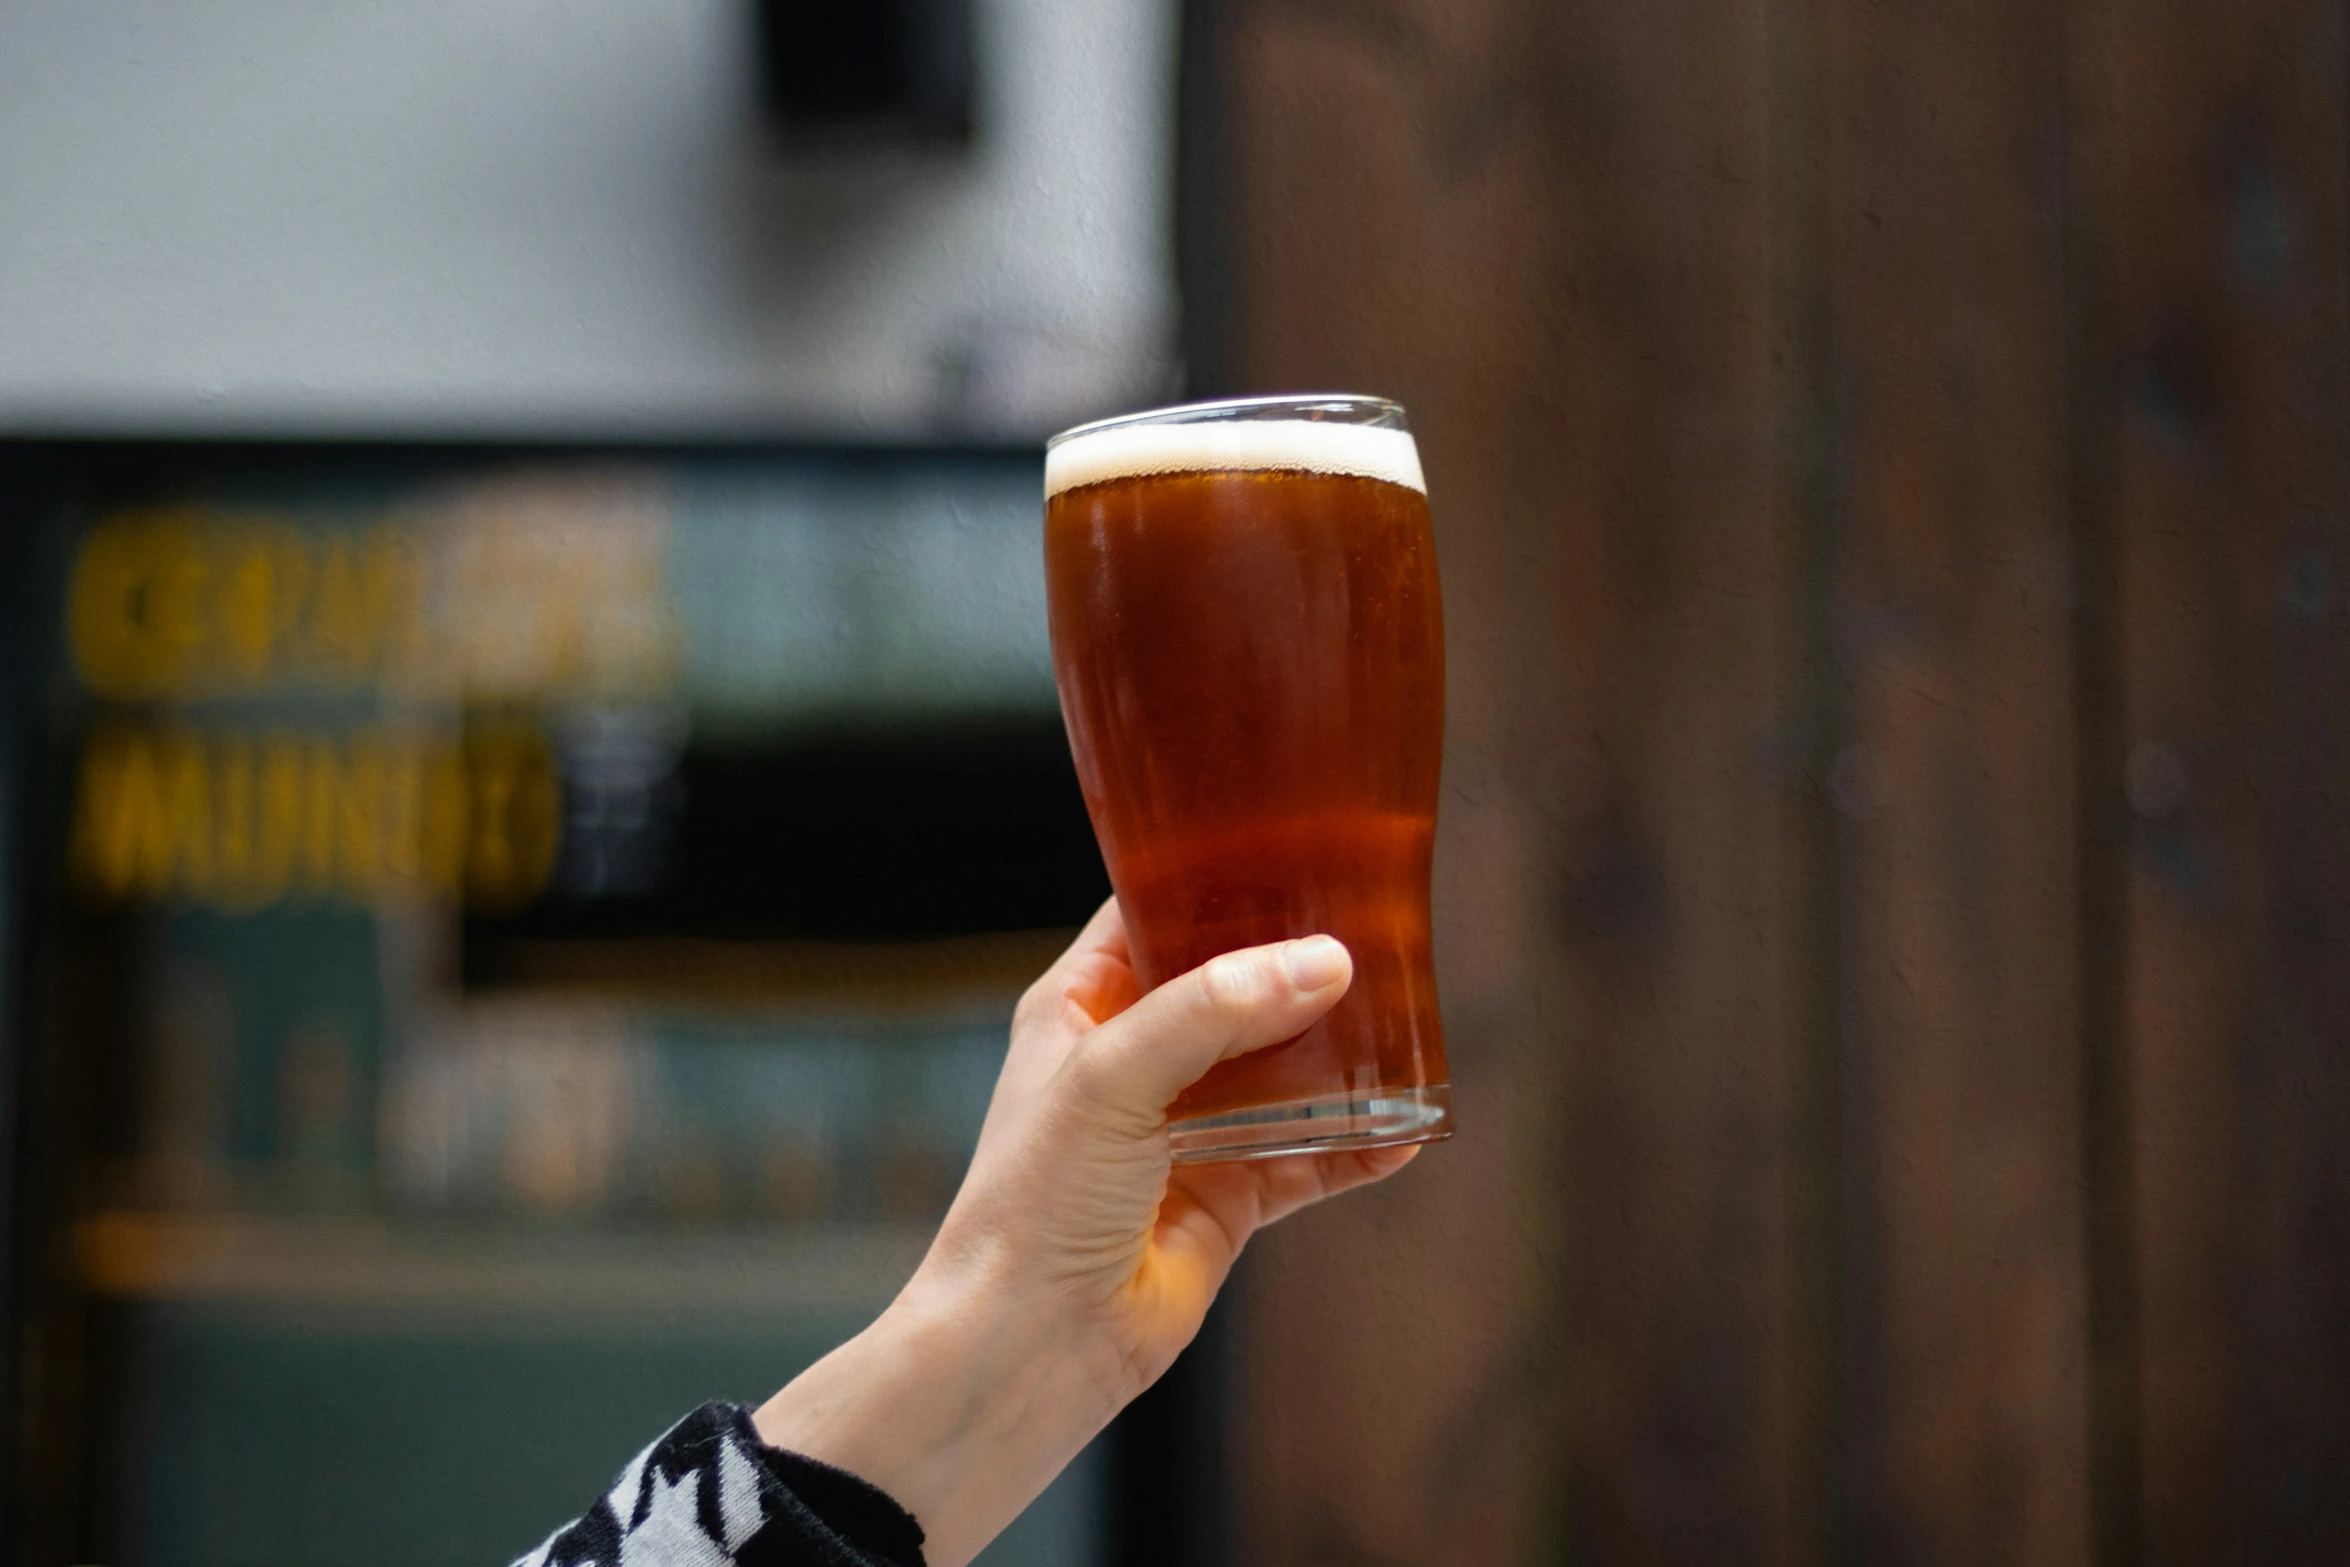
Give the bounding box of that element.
[0,0,2350,1567]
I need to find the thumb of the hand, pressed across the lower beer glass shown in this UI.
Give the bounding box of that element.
[1069,935,1354,1125]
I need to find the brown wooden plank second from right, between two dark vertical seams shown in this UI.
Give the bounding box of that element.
[1824,0,2089,1565]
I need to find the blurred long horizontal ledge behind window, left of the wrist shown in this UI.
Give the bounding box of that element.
[75,1212,933,1318]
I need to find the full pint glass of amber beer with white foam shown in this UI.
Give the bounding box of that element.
[1043,397,1452,1158]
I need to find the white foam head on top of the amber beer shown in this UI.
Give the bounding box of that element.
[1043,418,1429,500]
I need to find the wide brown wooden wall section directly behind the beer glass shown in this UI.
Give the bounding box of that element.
[1231,0,1791,1562]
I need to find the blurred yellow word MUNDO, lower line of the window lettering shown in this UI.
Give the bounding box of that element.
[73,726,562,914]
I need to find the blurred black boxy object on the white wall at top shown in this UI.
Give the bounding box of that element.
[757,0,975,146]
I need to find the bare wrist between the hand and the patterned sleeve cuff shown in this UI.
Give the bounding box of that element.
[754,1269,1126,1567]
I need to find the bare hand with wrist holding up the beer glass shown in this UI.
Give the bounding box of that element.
[754,900,1419,1567]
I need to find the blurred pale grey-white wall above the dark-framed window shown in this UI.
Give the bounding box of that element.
[0,0,1175,437]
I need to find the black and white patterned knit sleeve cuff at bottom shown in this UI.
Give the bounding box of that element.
[515,1405,924,1567]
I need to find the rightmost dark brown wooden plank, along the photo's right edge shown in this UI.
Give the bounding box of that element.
[2096,0,2350,1562]
